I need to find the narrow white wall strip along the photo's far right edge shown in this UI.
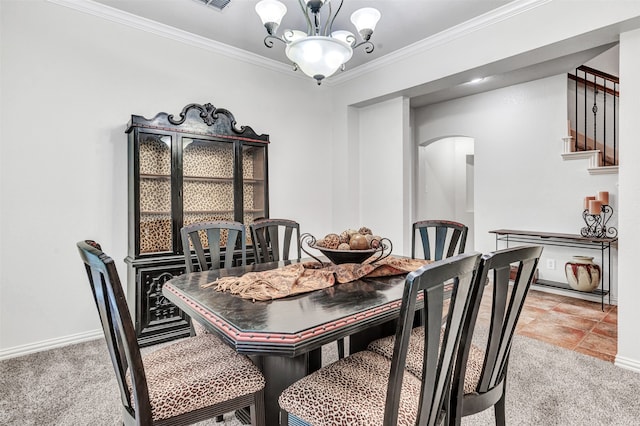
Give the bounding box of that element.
[616,30,640,371]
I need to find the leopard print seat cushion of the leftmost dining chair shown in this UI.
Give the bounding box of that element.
[127,334,265,421]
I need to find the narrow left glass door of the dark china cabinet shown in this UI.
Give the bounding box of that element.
[138,132,172,253]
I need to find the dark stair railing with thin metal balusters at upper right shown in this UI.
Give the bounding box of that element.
[568,65,620,166]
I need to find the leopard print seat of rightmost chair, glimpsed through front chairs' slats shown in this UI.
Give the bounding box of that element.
[367,327,484,394]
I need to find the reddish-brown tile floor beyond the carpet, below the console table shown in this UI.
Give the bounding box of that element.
[478,289,618,362]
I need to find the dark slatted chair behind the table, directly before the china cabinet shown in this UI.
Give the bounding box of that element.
[180,220,247,336]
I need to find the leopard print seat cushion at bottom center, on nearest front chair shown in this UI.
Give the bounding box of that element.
[278,351,420,426]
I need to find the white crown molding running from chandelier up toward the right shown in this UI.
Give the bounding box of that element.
[330,0,552,84]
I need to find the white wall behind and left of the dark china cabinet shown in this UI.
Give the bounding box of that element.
[0,0,332,357]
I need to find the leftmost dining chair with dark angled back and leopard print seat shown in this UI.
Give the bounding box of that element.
[77,240,265,425]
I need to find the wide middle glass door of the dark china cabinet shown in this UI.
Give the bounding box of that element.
[182,138,234,230]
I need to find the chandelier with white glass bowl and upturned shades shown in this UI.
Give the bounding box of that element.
[256,0,380,85]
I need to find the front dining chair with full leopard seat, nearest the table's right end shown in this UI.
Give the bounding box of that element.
[278,253,480,426]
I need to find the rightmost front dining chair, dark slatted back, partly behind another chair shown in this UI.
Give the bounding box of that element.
[449,246,542,426]
